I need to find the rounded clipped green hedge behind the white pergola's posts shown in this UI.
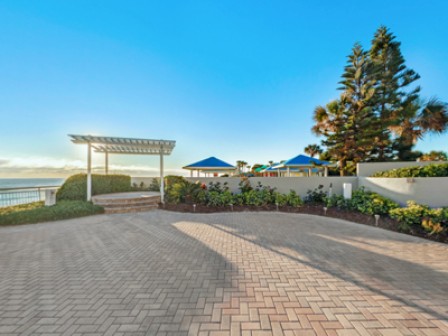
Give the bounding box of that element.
[56,174,131,202]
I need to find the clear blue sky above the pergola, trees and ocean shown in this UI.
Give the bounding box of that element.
[0,0,448,177]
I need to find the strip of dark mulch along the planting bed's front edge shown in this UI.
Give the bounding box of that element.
[159,203,448,244]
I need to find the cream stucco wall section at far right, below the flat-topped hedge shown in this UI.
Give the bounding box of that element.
[358,177,448,207]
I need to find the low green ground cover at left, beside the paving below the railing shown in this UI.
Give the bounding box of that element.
[0,201,104,225]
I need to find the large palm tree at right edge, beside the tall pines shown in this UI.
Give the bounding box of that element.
[391,98,448,160]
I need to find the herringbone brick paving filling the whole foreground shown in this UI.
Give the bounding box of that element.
[0,211,448,336]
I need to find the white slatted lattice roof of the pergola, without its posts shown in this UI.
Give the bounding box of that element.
[69,134,176,155]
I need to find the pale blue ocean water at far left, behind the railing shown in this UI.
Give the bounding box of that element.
[0,178,65,207]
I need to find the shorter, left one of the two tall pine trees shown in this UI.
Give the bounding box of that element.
[313,44,378,175]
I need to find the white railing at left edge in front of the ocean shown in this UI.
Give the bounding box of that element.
[0,186,60,207]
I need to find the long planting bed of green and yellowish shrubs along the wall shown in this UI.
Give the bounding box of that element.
[160,177,448,243]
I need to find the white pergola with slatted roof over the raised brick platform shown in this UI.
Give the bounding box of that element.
[68,134,176,202]
